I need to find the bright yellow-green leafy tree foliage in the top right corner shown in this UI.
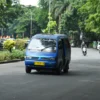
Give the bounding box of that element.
[79,0,100,34]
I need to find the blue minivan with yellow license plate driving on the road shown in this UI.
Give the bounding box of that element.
[25,34,71,74]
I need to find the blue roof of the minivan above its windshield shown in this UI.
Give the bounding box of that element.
[32,34,67,39]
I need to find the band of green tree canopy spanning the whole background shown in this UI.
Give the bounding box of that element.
[0,0,100,40]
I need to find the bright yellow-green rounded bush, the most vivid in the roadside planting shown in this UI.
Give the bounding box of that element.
[3,40,15,52]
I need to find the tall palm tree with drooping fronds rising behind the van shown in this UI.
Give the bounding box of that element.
[40,0,73,32]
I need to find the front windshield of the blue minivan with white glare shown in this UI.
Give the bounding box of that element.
[28,38,56,52]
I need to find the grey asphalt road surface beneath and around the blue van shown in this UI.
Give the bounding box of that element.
[0,48,100,100]
